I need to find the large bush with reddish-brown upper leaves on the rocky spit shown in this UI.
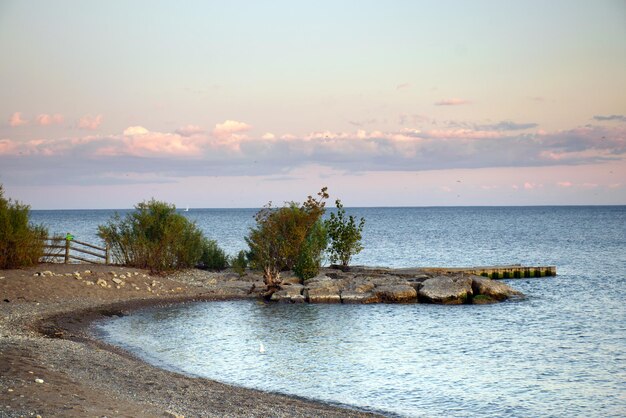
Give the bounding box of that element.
[246,187,328,288]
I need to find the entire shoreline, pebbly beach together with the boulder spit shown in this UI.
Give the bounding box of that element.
[0,264,520,417]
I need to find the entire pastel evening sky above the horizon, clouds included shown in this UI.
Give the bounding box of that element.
[0,0,626,209]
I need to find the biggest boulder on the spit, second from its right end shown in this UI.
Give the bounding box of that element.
[418,276,473,305]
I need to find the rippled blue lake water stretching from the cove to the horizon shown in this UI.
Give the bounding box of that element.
[31,206,626,417]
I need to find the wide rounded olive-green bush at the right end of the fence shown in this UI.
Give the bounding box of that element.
[98,199,207,273]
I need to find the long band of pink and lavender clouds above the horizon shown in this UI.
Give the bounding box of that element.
[0,120,626,184]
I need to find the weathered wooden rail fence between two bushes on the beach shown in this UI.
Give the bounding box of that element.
[43,238,111,264]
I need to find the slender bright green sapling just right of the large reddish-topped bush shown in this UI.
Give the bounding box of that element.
[325,199,365,266]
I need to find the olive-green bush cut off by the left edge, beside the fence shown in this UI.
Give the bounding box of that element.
[0,184,48,269]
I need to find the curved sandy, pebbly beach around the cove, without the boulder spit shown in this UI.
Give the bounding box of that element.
[0,264,372,418]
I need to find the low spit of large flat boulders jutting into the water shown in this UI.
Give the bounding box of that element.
[187,267,524,305]
